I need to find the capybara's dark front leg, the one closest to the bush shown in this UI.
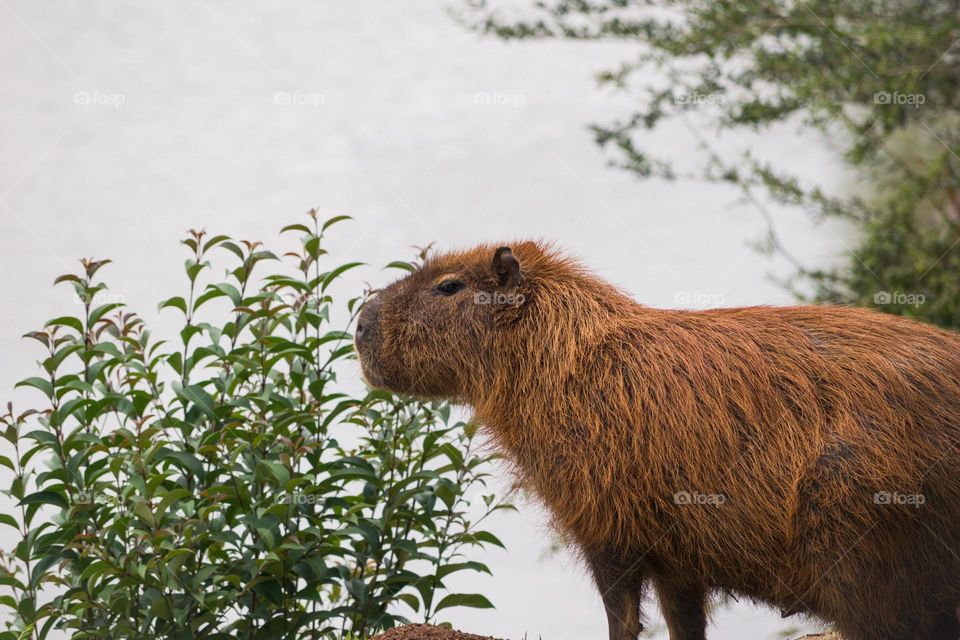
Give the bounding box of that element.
[588,552,643,640]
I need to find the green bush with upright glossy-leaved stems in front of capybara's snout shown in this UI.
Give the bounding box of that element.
[0,211,509,639]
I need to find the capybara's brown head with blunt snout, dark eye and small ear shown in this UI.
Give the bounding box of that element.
[355,242,544,398]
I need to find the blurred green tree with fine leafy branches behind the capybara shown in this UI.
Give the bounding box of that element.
[461,0,960,328]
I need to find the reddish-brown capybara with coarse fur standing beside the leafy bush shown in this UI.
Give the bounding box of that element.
[356,241,960,640]
